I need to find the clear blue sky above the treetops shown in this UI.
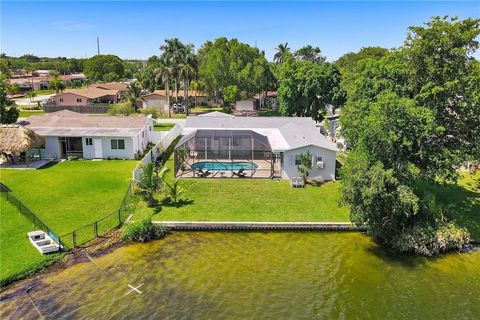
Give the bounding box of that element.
[0,0,480,61]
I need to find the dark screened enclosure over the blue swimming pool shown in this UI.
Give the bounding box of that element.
[174,130,278,178]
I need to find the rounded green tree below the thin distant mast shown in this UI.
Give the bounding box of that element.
[83,54,125,81]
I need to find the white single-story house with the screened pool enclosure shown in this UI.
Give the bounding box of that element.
[174,112,338,180]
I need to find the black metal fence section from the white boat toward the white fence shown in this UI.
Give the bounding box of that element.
[59,183,138,248]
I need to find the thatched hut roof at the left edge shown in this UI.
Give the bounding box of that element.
[0,124,45,152]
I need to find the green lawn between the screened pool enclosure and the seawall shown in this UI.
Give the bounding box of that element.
[133,160,349,222]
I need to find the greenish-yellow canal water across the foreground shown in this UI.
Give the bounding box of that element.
[0,232,480,319]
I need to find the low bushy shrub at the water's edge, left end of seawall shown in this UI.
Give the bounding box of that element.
[122,216,169,242]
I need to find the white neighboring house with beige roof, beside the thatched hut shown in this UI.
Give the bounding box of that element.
[26,110,153,159]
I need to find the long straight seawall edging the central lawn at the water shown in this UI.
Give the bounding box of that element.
[152,221,365,231]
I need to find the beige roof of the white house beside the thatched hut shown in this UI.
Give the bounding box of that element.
[27,110,148,137]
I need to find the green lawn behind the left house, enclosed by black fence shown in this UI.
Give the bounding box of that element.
[0,160,137,235]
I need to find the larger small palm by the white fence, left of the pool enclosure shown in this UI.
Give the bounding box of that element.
[133,163,168,207]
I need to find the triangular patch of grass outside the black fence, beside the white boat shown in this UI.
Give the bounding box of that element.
[0,196,62,286]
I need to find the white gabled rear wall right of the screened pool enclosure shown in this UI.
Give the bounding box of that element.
[282,146,336,181]
